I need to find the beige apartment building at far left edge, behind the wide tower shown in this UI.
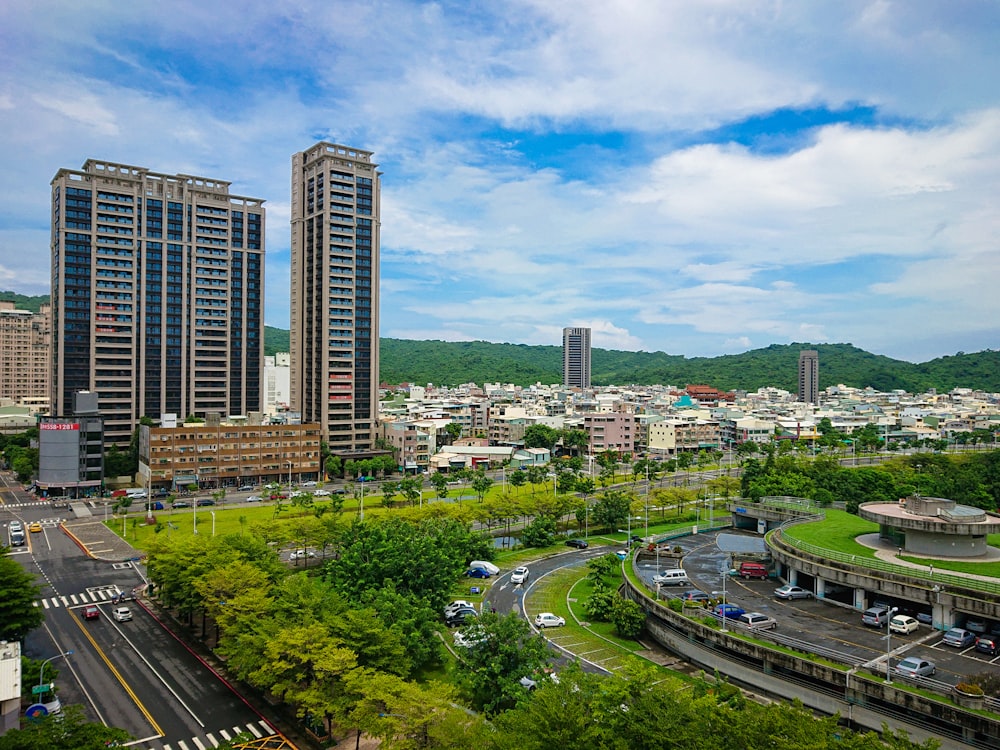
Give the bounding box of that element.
[0,300,52,412]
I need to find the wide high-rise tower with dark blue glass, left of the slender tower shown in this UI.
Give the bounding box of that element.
[52,159,264,445]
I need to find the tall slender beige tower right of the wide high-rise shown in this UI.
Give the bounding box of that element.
[290,142,381,453]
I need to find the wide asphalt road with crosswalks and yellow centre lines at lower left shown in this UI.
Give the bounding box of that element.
[0,475,274,750]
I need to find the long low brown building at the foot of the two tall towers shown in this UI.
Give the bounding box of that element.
[139,422,323,490]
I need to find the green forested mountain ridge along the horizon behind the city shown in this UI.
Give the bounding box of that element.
[7,292,1000,393]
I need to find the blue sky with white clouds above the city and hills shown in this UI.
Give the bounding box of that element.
[0,0,1000,362]
